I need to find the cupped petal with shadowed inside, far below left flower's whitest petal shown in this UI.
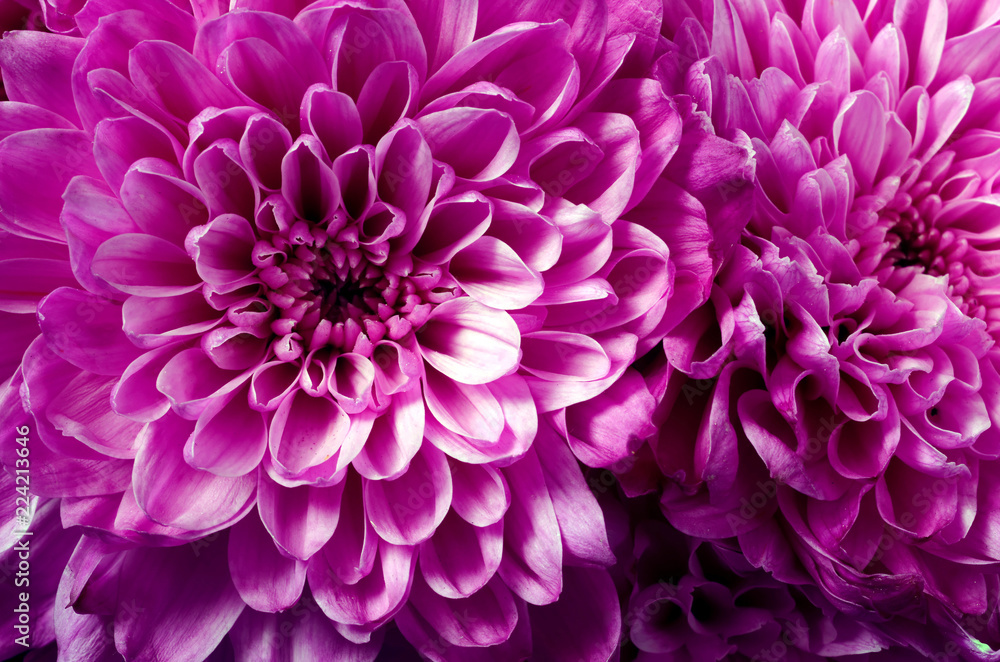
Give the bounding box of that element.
[420,512,503,599]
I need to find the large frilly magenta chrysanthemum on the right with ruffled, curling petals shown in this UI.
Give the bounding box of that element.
[608,0,1000,655]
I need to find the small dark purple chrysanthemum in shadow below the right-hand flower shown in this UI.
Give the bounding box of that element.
[601,491,960,662]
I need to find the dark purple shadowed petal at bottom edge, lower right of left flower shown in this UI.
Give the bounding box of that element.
[528,567,621,662]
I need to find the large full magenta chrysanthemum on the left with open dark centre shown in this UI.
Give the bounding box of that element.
[0,0,752,660]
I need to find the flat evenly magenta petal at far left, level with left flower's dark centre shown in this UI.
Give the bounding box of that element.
[38,288,140,375]
